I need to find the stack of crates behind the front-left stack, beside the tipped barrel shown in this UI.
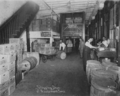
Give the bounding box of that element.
[9,38,24,85]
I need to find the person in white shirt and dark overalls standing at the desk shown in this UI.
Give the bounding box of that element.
[83,38,98,71]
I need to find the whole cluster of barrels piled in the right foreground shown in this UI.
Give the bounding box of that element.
[86,49,120,96]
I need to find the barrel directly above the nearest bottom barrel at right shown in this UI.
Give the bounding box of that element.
[90,69,117,81]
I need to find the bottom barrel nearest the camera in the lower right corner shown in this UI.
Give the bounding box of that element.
[90,79,118,96]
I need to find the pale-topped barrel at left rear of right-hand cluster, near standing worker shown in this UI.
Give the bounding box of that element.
[86,60,103,83]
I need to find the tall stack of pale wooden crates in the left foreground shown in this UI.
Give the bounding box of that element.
[0,44,16,96]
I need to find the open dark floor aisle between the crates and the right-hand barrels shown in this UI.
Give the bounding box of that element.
[11,54,89,96]
